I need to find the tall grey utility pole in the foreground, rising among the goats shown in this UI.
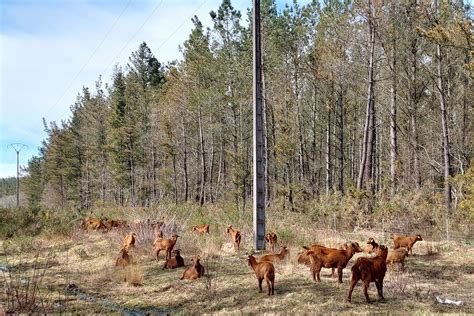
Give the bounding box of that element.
[253,0,265,250]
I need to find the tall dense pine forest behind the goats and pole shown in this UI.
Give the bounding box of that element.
[22,0,474,217]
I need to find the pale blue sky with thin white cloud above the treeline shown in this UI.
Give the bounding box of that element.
[0,0,309,178]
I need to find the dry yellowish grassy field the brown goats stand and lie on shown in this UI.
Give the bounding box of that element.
[0,207,474,315]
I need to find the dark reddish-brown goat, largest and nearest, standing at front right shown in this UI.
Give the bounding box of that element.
[347,245,388,303]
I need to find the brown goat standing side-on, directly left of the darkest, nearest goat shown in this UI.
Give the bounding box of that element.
[308,242,362,283]
